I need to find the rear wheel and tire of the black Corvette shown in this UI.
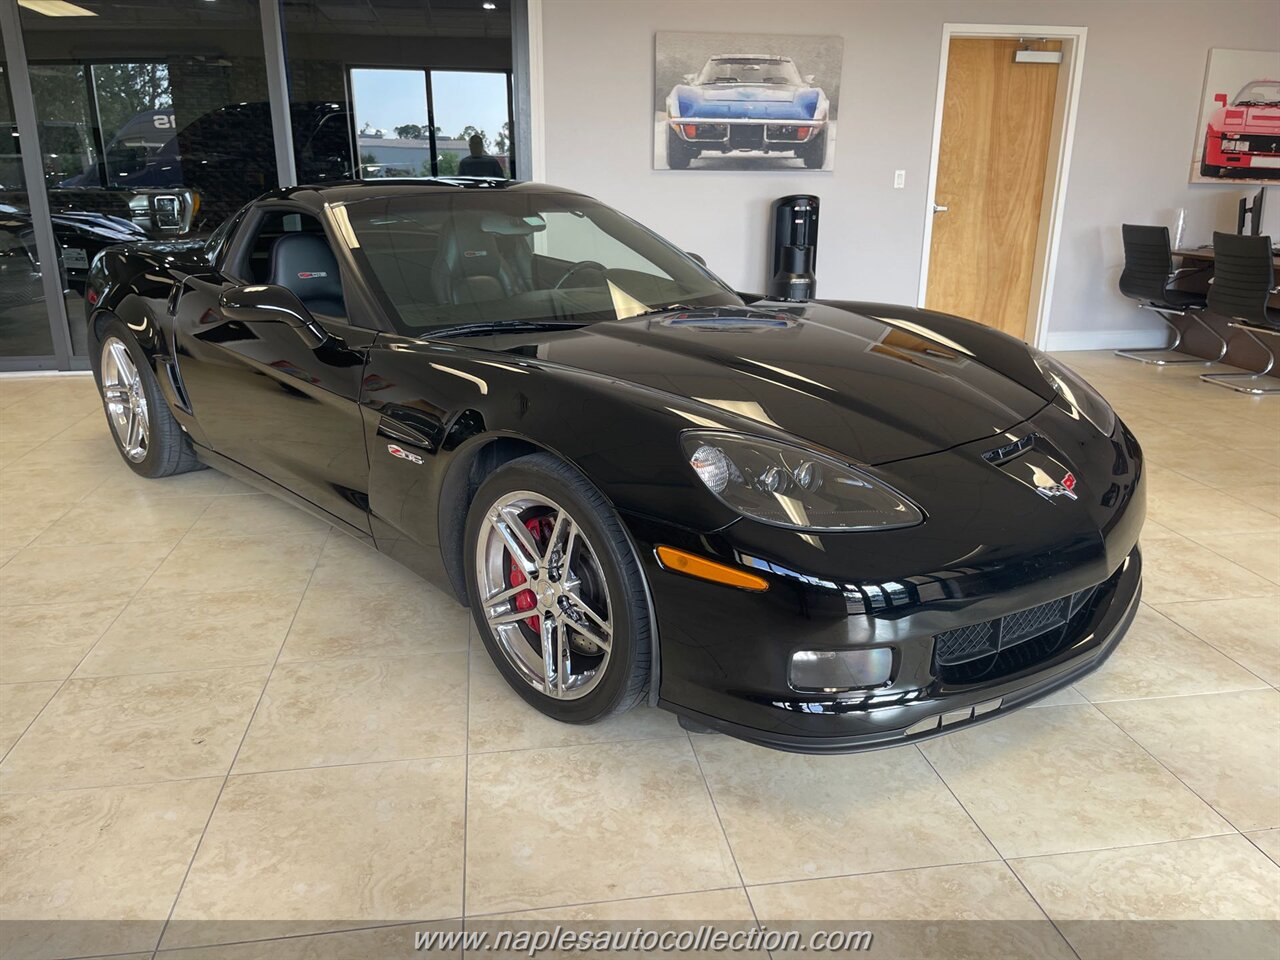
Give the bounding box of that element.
[93,317,201,479]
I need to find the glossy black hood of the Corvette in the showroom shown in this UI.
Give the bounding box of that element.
[493,303,1046,463]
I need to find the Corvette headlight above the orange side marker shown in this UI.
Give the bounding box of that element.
[681,430,924,530]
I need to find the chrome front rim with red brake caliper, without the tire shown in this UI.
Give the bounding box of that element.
[475,490,613,700]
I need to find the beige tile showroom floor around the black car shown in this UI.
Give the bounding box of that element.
[0,353,1280,960]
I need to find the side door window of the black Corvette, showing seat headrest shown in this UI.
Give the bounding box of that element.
[242,210,347,319]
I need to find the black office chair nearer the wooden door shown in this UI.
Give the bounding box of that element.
[1116,223,1226,366]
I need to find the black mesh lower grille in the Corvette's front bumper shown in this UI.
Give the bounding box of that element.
[933,586,1098,684]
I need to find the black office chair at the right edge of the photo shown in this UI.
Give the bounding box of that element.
[1201,233,1280,394]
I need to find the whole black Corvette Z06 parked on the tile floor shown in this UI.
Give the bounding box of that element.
[88,180,1144,751]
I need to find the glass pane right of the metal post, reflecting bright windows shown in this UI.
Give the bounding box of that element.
[284,0,517,182]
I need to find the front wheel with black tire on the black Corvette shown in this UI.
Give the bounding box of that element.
[465,453,650,723]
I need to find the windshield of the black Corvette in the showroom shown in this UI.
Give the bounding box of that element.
[342,189,742,337]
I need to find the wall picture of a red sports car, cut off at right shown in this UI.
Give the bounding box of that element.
[1190,49,1280,184]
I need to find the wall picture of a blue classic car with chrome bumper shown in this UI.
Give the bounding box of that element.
[653,33,844,170]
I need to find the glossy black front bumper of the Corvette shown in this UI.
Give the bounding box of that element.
[628,404,1146,753]
